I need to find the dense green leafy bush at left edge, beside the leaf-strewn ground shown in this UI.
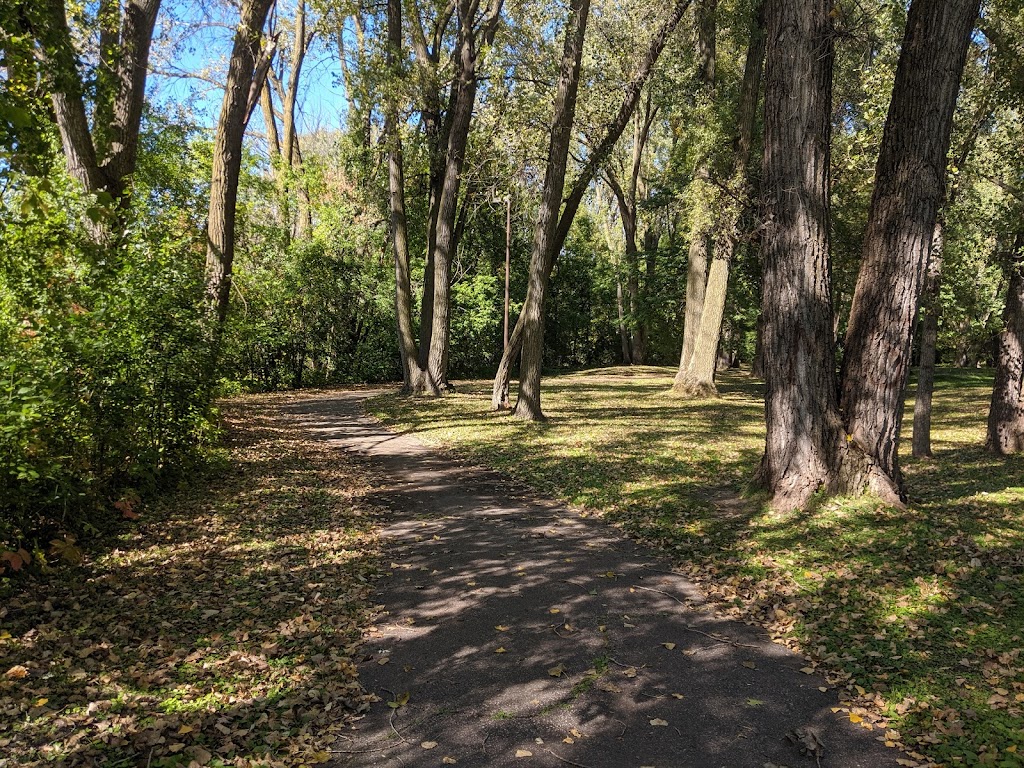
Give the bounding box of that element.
[0,137,211,549]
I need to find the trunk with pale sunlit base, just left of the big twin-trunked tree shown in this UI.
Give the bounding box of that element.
[672,0,765,397]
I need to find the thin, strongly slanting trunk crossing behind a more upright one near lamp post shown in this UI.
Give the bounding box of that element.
[490,0,691,418]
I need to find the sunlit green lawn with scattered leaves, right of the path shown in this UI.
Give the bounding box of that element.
[374,368,1024,766]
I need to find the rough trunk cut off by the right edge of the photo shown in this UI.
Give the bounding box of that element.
[985,234,1024,455]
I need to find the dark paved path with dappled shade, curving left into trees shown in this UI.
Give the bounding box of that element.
[285,392,899,768]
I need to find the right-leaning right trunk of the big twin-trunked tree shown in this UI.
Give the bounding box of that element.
[841,0,979,498]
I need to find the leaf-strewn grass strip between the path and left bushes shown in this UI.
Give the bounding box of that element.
[0,393,385,768]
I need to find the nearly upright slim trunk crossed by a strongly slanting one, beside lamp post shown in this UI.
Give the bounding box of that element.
[503,0,590,421]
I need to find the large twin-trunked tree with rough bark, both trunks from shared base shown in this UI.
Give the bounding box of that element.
[759,0,979,508]
